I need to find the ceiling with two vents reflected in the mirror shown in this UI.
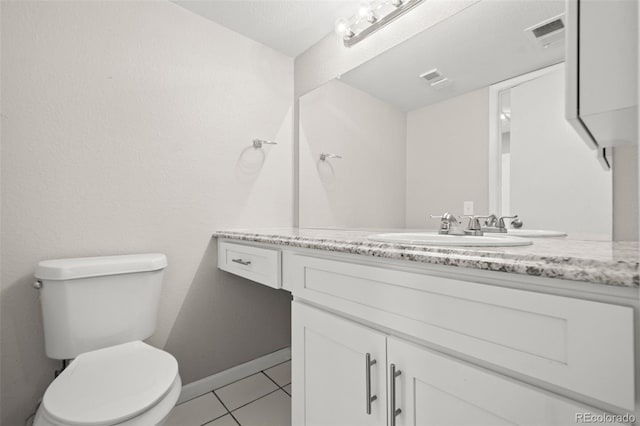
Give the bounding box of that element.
[340,0,565,111]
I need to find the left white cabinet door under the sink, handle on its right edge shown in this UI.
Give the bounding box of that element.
[291,301,387,426]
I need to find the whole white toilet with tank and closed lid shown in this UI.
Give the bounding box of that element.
[33,254,182,426]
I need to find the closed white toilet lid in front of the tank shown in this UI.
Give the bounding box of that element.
[42,341,178,426]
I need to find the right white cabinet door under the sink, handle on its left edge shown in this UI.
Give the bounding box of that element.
[387,337,624,426]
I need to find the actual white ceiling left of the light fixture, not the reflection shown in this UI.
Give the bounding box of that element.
[172,0,359,57]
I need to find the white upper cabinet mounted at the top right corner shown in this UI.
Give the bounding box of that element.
[566,0,638,148]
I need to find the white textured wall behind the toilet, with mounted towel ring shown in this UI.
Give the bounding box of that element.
[1,1,293,425]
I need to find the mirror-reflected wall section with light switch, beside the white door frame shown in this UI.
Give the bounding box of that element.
[406,88,489,229]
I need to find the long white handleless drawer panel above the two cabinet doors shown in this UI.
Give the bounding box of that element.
[285,255,635,410]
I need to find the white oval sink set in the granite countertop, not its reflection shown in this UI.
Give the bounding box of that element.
[369,232,532,247]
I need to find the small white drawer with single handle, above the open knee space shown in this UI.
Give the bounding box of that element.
[218,241,282,288]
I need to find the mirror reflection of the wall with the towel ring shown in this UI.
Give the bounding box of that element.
[299,80,406,228]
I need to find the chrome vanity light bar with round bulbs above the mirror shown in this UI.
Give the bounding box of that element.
[335,0,424,47]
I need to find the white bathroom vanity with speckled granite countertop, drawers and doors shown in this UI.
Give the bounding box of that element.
[214,229,640,426]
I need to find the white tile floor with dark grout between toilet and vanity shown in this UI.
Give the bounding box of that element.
[165,361,291,426]
